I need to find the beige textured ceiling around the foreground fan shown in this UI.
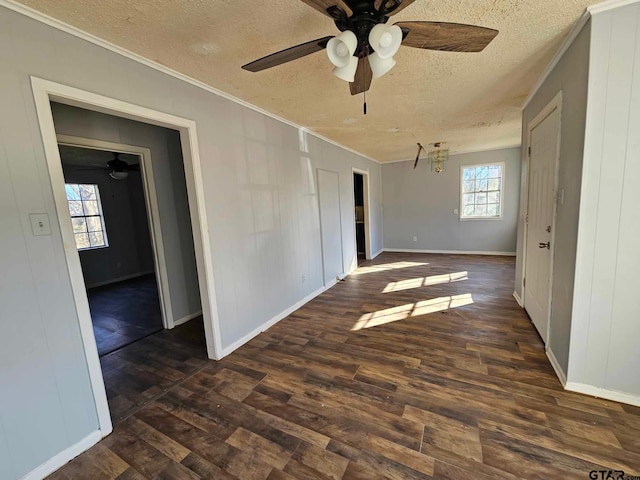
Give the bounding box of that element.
[21,0,599,161]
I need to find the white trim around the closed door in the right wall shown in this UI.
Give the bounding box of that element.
[516,90,563,349]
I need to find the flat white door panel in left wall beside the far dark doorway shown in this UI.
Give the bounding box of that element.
[318,169,342,285]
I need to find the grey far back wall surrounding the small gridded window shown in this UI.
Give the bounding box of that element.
[382,148,520,253]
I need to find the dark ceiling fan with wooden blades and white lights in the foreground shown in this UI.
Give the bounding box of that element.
[242,0,498,95]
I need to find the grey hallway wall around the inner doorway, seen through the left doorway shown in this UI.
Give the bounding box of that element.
[51,102,202,321]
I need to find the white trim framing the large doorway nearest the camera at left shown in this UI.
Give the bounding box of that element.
[31,76,222,437]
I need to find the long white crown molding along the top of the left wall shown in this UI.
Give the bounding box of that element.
[0,0,381,164]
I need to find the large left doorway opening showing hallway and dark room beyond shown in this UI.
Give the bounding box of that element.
[51,102,207,423]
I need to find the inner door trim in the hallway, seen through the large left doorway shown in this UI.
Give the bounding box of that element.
[57,135,175,329]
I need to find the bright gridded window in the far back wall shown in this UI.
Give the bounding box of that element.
[460,163,504,220]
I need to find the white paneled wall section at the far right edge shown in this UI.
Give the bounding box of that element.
[568,3,640,405]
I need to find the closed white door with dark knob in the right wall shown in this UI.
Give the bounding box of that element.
[524,108,560,344]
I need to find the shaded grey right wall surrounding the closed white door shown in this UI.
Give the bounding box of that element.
[515,23,591,375]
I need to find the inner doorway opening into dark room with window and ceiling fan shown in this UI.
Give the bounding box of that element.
[58,142,167,357]
